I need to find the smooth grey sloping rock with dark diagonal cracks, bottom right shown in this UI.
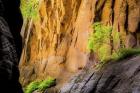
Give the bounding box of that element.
[59,56,140,93]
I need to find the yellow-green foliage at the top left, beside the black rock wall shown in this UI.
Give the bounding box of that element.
[20,0,39,18]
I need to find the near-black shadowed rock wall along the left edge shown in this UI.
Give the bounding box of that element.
[0,0,23,93]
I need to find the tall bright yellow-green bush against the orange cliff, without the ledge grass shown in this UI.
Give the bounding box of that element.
[88,22,112,61]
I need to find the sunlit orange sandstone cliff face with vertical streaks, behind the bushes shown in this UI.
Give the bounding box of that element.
[20,0,140,88]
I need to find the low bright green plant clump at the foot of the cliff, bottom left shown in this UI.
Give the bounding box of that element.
[25,77,56,93]
